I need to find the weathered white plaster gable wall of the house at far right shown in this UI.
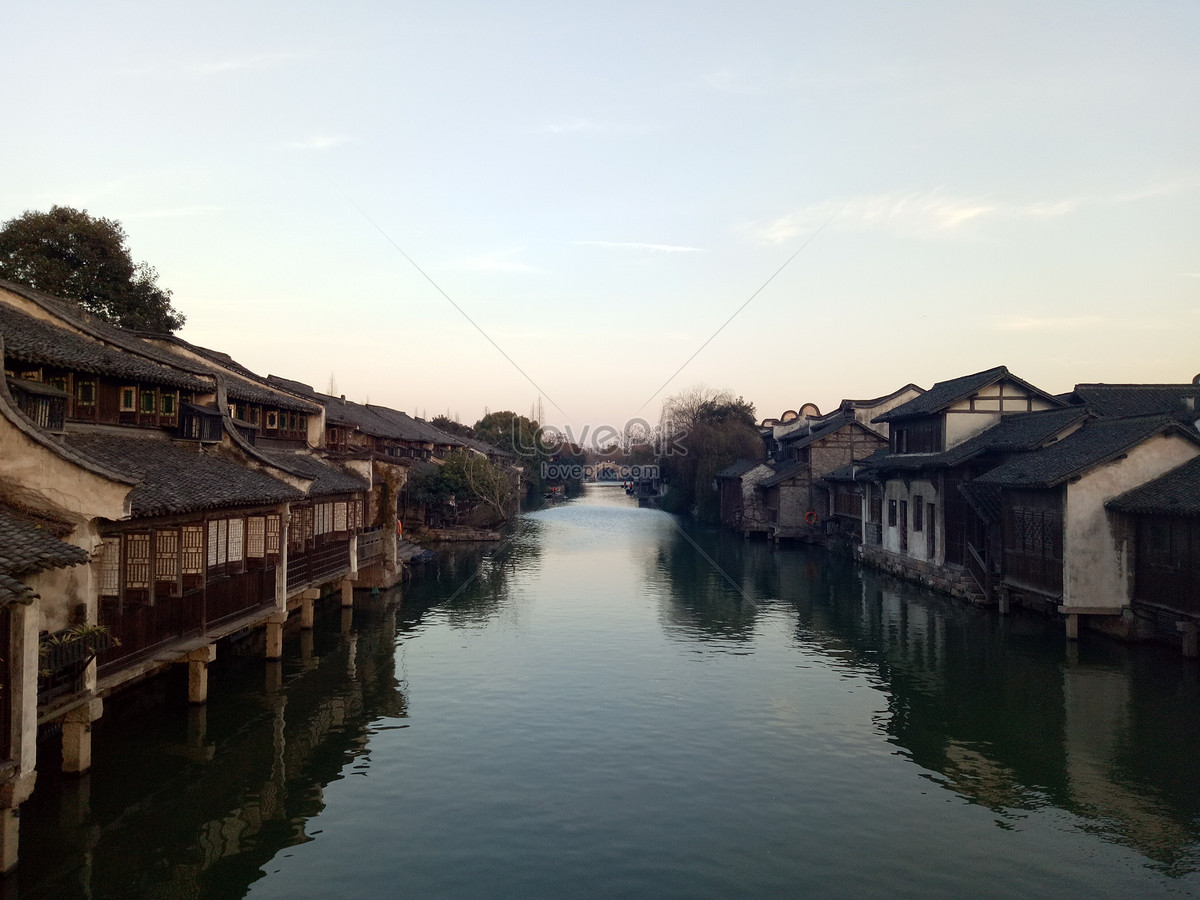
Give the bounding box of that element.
[1062,434,1200,610]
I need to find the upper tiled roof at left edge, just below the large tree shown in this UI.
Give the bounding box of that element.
[0,302,212,392]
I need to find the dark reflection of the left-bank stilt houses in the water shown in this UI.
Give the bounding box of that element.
[10,594,412,898]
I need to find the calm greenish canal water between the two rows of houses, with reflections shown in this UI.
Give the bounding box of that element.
[6,487,1200,900]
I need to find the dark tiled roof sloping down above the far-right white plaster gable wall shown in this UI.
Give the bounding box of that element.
[976,415,1200,487]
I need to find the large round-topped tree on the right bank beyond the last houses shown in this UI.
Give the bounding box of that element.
[659,388,763,521]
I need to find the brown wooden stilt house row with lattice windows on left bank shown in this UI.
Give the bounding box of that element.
[0,282,395,870]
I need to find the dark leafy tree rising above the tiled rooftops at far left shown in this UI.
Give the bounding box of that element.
[0,206,184,334]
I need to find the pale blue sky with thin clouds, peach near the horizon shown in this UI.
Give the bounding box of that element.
[0,0,1200,437]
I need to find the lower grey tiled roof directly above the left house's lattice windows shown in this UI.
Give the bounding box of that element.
[62,433,304,516]
